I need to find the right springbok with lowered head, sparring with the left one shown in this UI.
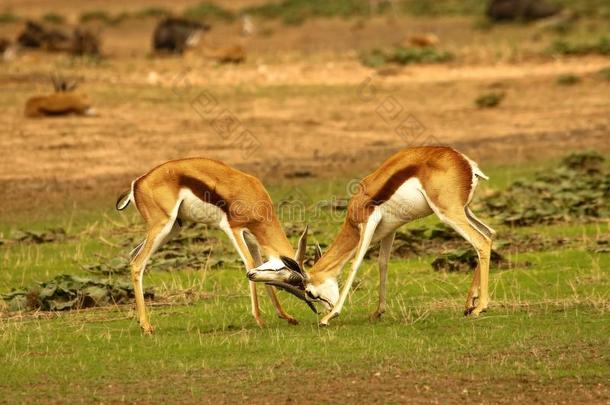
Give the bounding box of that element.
[248,146,495,325]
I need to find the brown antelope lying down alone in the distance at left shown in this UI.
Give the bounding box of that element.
[24,76,96,118]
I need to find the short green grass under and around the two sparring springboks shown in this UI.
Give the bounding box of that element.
[0,159,610,402]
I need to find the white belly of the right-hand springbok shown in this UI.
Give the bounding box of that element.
[373,178,432,241]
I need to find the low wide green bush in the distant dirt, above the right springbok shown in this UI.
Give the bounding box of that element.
[360,46,453,67]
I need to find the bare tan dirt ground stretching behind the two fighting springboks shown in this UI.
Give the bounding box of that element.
[0,0,610,214]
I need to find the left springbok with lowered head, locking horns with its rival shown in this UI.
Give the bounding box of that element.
[116,158,314,334]
